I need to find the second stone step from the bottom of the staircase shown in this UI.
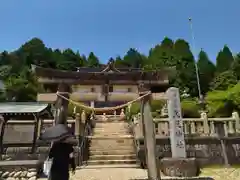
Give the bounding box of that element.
[87,159,137,165]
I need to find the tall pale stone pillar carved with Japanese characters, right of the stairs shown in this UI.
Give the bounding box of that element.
[167,87,186,158]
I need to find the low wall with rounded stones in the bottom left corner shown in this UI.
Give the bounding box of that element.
[0,161,41,180]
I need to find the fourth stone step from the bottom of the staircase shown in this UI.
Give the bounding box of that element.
[89,148,135,156]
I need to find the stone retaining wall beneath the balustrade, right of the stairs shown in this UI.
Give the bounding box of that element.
[138,137,240,166]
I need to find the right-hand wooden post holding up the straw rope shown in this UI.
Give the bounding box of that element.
[141,95,160,180]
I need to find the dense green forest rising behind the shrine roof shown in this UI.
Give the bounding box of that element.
[0,38,240,116]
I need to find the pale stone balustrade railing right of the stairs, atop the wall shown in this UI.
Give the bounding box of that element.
[135,112,240,137]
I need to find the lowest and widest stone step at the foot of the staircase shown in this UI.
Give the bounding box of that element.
[77,164,141,169]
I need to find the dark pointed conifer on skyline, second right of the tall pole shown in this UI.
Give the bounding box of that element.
[216,45,234,73]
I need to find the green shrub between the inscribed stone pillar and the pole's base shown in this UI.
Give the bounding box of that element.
[181,99,200,118]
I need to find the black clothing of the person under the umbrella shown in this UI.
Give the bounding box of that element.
[49,142,75,180]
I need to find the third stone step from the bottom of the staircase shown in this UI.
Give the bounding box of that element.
[89,154,136,160]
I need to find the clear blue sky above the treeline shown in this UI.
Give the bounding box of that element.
[0,0,240,62]
